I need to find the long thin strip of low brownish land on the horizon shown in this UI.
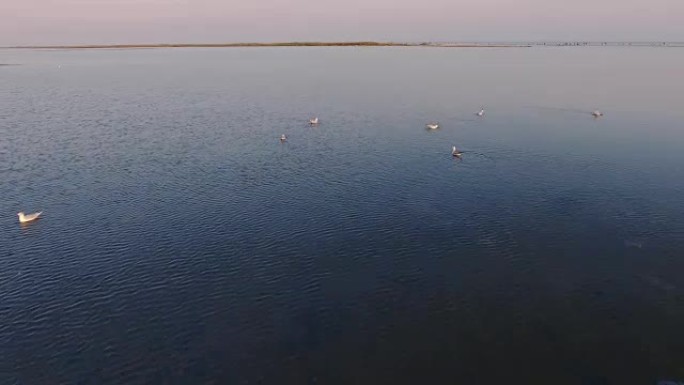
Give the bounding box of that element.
[2,41,530,49]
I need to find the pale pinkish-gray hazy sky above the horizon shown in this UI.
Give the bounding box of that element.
[0,0,684,46]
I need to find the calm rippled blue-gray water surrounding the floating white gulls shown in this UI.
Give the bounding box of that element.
[0,47,684,385]
